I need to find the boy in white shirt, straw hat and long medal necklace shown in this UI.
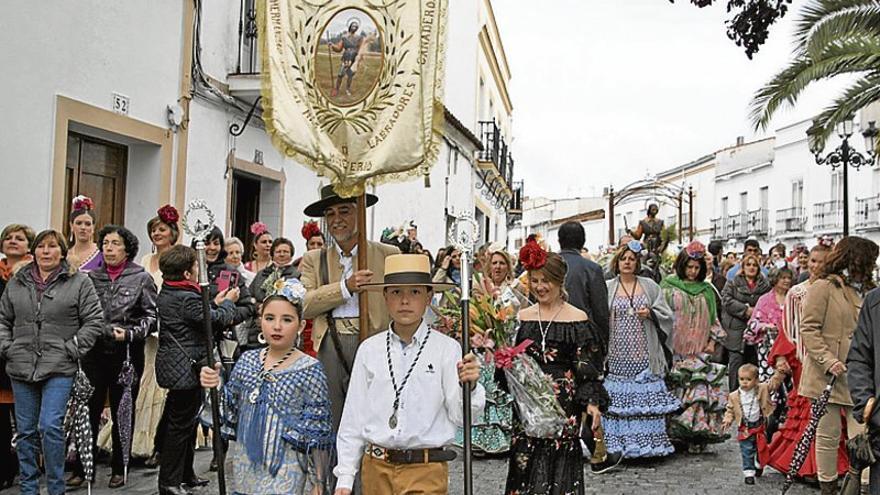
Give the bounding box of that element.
[333,254,486,495]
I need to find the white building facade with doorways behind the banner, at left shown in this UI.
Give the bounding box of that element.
[0,0,513,251]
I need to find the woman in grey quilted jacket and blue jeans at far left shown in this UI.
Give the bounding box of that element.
[0,230,103,495]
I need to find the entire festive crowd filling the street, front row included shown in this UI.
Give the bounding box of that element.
[0,192,880,495]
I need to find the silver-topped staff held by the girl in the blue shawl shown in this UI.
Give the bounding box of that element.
[183,199,226,495]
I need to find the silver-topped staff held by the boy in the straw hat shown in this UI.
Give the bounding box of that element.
[449,213,479,495]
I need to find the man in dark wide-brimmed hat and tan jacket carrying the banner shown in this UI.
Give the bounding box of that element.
[299,186,399,431]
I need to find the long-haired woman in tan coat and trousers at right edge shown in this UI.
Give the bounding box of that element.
[798,236,880,495]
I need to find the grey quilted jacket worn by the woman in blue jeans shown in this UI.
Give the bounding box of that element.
[0,261,103,383]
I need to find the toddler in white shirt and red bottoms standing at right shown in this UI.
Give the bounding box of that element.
[722,364,777,485]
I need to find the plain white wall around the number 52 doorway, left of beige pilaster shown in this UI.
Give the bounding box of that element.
[0,0,183,230]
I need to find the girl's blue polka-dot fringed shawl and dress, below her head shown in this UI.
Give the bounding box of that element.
[223,350,336,495]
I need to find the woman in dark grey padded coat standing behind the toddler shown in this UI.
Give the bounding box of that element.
[721,254,770,392]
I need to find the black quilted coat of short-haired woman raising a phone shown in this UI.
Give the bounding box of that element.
[156,283,235,390]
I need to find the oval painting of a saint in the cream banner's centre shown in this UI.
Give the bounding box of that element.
[315,8,383,107]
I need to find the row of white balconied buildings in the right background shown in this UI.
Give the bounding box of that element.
[510,106,880,252]
